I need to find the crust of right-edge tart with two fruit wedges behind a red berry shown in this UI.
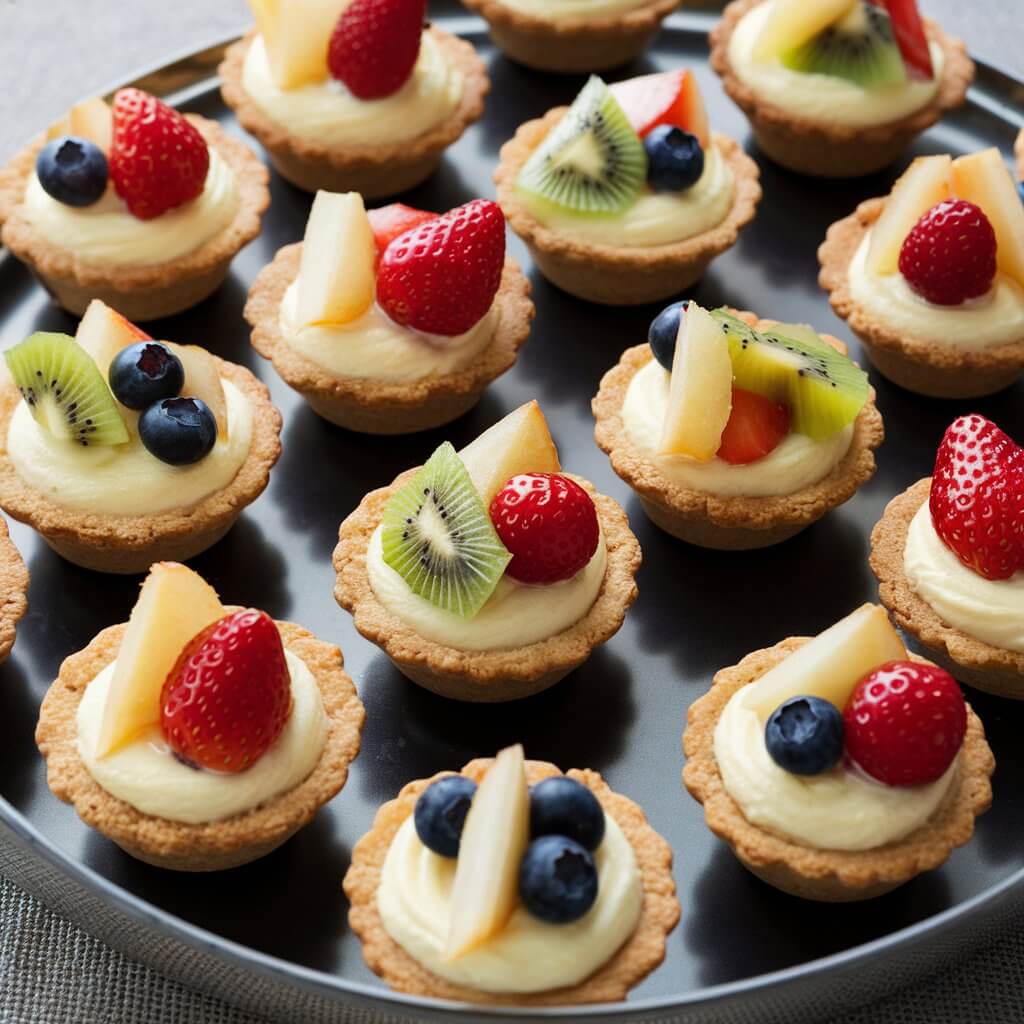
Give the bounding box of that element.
[818,197,1024,398]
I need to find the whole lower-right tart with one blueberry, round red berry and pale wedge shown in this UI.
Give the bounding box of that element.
[683,604,995,902]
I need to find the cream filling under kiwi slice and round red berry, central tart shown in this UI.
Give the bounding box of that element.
[367,526,607,650]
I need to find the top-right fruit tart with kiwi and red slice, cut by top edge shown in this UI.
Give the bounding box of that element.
[711,0,974,178]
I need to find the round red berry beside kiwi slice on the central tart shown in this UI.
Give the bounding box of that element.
[490,473,600,584]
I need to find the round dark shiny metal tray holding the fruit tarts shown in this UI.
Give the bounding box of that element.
[0,3,1024,1024]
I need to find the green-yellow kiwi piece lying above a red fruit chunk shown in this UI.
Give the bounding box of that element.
[712,309,868,441]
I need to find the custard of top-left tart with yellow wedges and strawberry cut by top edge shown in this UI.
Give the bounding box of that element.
[242,32,463,146]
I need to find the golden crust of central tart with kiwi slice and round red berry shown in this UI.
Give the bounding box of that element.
[334,469,640,702]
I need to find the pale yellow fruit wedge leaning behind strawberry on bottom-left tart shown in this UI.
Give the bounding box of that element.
[96,562,226,758]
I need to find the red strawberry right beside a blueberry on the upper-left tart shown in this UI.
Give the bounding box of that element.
[110,89,210,220]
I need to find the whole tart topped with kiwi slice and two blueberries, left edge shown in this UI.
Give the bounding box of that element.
[0,299,281,572]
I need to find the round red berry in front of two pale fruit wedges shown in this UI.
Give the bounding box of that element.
[899,199,995,306]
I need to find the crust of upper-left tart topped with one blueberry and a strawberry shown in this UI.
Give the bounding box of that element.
[0,114,270,322]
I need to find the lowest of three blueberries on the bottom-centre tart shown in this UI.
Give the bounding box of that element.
[519,836,597,925]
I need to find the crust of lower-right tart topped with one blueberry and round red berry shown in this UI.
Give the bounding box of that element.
[683,637,995,902]
